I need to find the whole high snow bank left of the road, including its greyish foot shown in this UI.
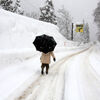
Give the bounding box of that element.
[0,9,66,64]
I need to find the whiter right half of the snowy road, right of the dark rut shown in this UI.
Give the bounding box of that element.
[63,48,100,100]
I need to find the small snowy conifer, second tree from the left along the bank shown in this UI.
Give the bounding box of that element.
[13,0,24,15]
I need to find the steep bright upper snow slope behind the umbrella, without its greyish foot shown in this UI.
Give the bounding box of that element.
[0,9,66,49]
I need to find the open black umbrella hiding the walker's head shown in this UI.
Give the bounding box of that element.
[33,34,57,53]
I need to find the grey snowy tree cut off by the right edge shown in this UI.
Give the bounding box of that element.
[94,2,100,41]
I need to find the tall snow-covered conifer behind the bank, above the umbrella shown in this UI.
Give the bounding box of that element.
[39,0,57,24]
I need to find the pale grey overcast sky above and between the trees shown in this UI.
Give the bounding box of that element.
[22,0,99,40]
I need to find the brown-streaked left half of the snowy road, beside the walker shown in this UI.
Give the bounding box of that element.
[15,48,89,100]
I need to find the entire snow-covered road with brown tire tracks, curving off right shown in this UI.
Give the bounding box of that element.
[13,47,100,100]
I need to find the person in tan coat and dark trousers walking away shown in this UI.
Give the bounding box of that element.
[40,51,56,75]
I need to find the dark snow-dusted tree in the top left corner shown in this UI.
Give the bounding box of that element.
[0,0,13,11]
